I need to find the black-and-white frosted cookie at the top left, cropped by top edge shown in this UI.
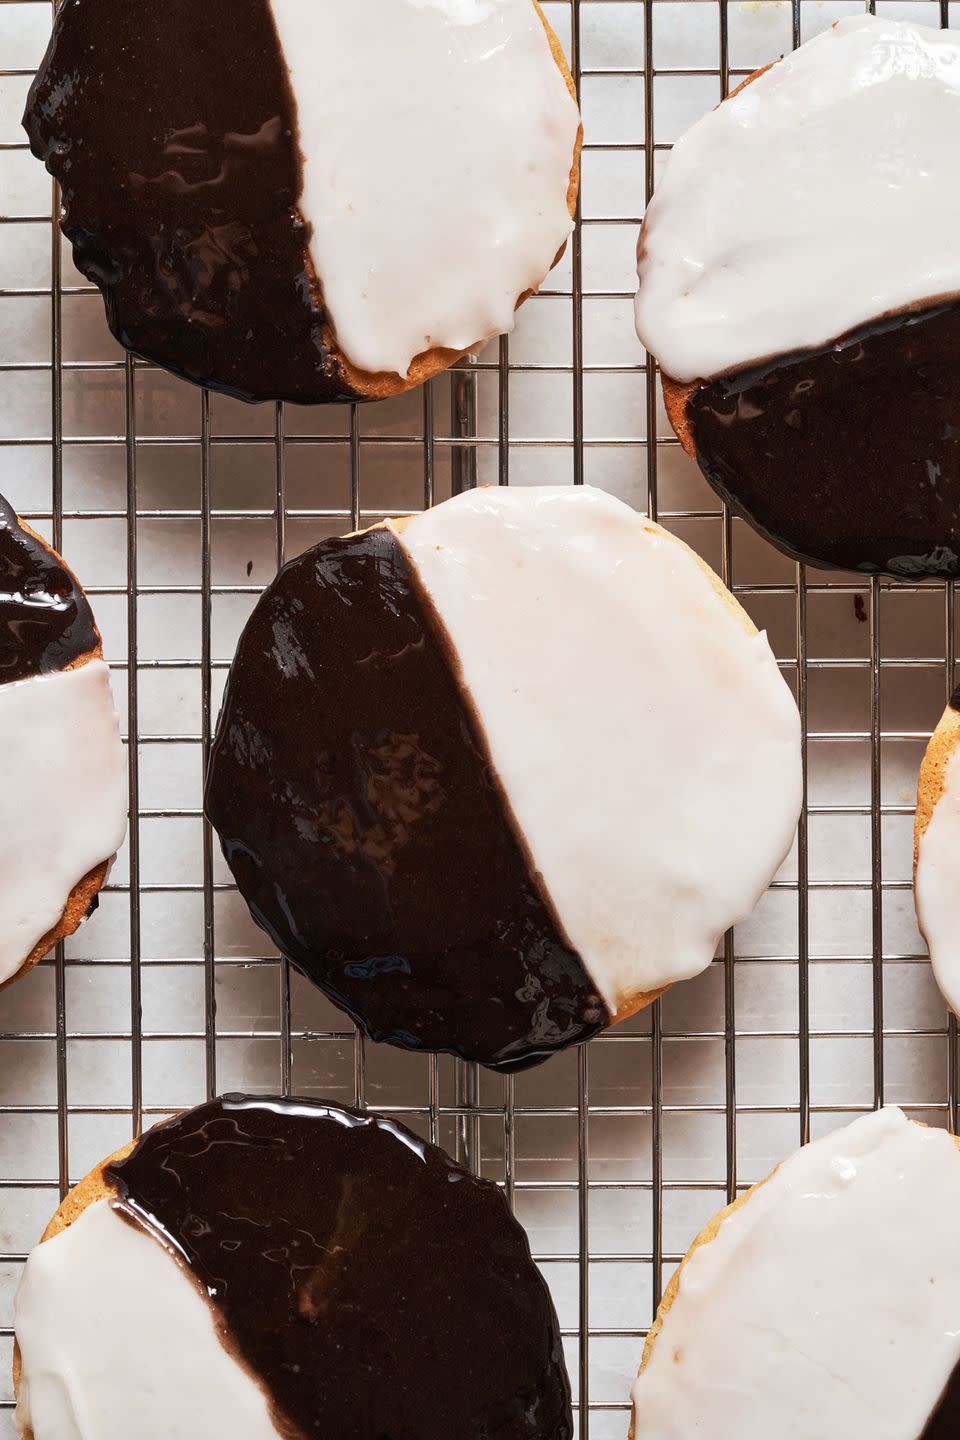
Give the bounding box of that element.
[24,0,581,403]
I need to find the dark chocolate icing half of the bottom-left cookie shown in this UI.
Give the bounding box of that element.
[107,1096,573,1440]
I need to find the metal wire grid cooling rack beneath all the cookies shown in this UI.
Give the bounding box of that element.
[0,0,960,1440]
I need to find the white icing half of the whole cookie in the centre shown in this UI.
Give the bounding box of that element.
[391,487,802,1012]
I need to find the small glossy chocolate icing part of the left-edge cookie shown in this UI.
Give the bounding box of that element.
[0,495,99,684]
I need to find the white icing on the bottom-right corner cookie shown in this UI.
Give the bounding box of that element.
[633,1109,960,1440]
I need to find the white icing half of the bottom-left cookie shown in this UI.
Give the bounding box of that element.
[16,1200,278,1440]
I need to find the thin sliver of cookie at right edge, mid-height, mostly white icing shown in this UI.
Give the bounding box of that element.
[914,691,960,1014]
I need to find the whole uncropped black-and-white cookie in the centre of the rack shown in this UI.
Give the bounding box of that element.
[206,487,802,1070]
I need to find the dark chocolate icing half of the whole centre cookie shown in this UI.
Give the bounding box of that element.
[206,527,609,1068]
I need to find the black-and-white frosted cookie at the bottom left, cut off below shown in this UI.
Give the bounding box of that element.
[14,1096,573,1440]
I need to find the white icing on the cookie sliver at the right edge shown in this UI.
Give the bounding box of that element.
[914,747,960,1015]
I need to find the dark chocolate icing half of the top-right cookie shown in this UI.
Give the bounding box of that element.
[687,302,960,577]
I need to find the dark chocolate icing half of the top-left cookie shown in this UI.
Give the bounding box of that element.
[23,0,354,402]
